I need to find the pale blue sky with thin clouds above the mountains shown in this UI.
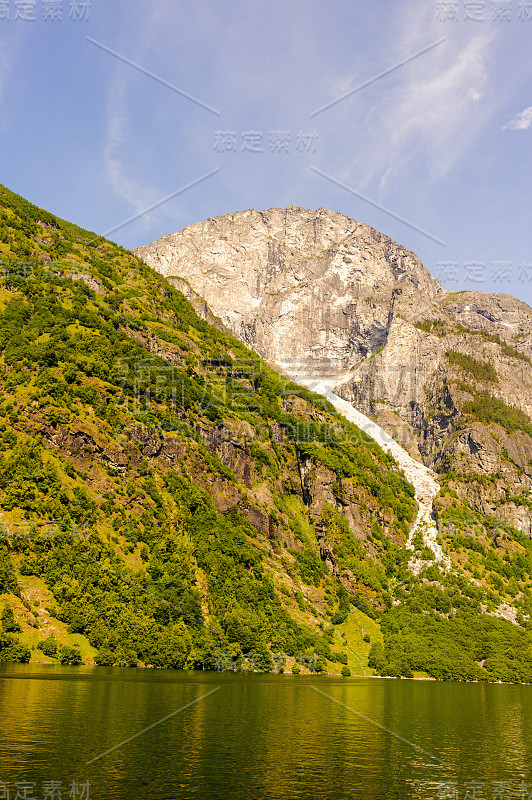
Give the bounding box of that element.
[0,0,532,303]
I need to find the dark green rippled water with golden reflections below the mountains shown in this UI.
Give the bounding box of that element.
[0,664,532,800]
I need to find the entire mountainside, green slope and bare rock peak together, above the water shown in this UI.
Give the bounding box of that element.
[0,186,532,683]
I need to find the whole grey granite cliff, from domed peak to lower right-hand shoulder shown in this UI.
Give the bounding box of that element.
[135,206,532,536]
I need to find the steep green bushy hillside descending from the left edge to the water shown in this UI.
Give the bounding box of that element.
[0,184,415,670]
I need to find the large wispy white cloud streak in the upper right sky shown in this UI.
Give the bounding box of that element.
[332,3,497,199]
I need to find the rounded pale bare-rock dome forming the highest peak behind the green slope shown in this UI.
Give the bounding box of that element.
[135,206,441,376]
